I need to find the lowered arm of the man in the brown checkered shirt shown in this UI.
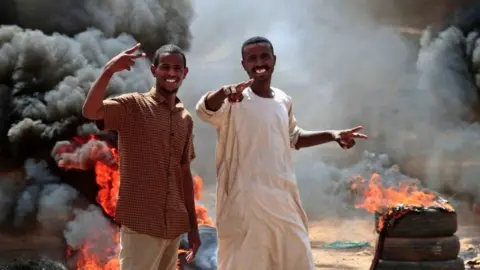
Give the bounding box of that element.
[182,121,198,231]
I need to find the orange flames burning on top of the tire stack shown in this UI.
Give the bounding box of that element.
[351,173,455,231]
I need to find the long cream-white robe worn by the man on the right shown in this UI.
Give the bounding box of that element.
[196,89,315,270]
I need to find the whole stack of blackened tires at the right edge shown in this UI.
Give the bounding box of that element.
[375,209,465,270]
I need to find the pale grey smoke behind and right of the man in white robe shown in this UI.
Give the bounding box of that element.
[182,0,480,217]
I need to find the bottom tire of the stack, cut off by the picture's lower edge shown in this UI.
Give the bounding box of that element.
[375,258,465,270]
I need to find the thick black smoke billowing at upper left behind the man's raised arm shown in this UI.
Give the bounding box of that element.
[0,0,193,169]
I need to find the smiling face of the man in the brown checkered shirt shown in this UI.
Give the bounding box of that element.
[151,52,188,93]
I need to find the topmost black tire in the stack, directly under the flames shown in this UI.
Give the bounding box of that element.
[375,209,458,238]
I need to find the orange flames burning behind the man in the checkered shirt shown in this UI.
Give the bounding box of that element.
[53,136,214,270]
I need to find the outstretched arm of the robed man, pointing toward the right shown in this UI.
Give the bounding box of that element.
[288,99,368,150]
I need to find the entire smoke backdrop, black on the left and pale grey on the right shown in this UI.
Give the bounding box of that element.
[0,0,480,264]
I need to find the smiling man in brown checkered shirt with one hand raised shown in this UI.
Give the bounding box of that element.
[83,44,200,270]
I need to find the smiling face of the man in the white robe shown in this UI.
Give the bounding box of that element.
[242,42,276,81]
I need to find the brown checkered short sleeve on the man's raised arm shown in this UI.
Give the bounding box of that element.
[102,94,135,131]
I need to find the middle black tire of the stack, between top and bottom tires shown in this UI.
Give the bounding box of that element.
[380,235,460,262]
